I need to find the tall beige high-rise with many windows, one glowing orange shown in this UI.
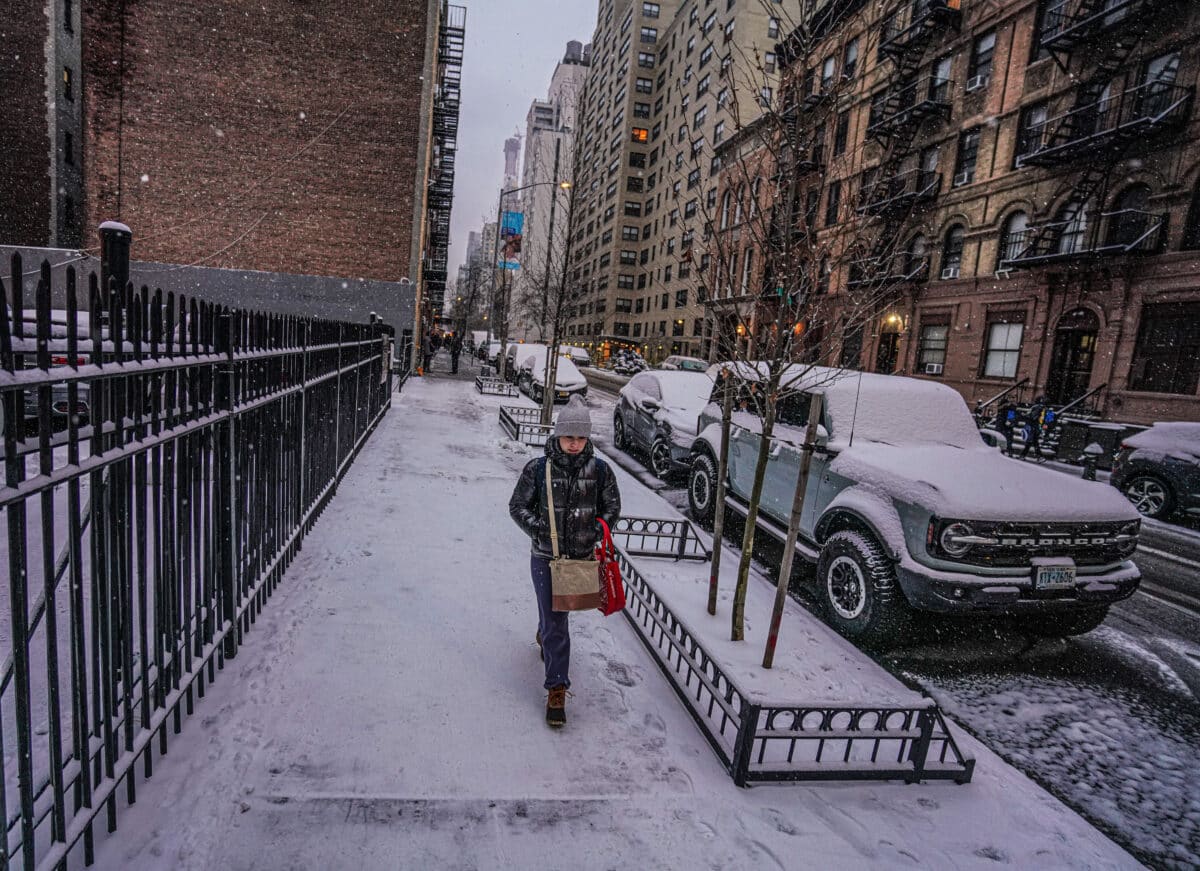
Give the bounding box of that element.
[568,0,802,361]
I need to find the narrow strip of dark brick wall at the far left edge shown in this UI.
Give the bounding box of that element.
[0,2,50,245]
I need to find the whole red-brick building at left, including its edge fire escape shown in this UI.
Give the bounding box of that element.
[0,0,463,331]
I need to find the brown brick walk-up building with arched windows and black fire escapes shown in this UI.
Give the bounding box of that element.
[744,0,1200,422]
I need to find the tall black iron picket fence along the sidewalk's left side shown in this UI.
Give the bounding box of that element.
[0,258,391,869]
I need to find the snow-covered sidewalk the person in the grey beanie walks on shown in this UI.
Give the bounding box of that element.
[88,379,1136,871]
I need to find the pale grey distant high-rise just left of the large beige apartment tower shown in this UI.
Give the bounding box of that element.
[509,40,592,341]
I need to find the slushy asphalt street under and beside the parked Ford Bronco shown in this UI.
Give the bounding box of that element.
[589,382,1200,867]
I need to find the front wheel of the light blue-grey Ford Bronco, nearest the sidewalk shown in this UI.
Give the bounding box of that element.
[817,530,910,643]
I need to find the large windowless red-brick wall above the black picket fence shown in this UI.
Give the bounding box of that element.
[84,0,428,280]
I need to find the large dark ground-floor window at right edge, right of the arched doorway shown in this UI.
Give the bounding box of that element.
[1129,302,1200,395]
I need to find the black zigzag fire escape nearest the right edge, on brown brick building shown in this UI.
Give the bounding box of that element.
[1000,0,1194,269]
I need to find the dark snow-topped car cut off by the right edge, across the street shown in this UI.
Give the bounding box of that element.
[1109,422,1200,519]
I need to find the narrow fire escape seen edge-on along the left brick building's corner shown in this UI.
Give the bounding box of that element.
[421,5,467,313]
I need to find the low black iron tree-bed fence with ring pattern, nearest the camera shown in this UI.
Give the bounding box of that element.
[617,547,974,786]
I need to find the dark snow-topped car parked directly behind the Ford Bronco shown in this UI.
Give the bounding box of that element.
[612,370,713,477]
